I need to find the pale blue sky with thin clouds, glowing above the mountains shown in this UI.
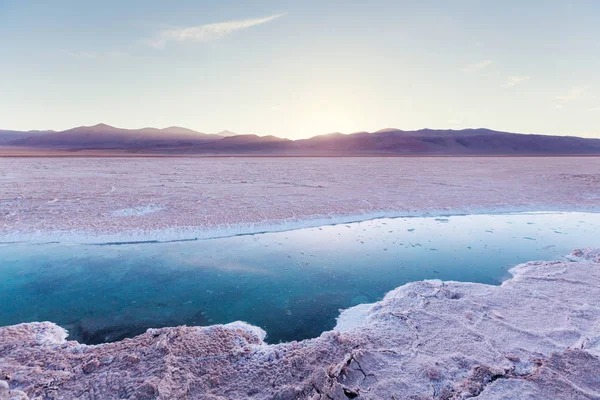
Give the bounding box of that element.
[0,0,600,139]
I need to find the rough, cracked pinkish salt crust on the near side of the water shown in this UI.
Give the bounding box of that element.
[0,250,600,400]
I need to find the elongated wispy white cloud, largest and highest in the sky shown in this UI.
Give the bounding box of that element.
[148,14,285,49]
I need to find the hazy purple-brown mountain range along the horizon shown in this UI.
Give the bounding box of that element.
[0,124,600,156]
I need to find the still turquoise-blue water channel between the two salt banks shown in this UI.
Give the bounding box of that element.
[0,213,600,343]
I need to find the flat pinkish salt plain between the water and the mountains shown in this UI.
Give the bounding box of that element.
[0,157,600,241]
